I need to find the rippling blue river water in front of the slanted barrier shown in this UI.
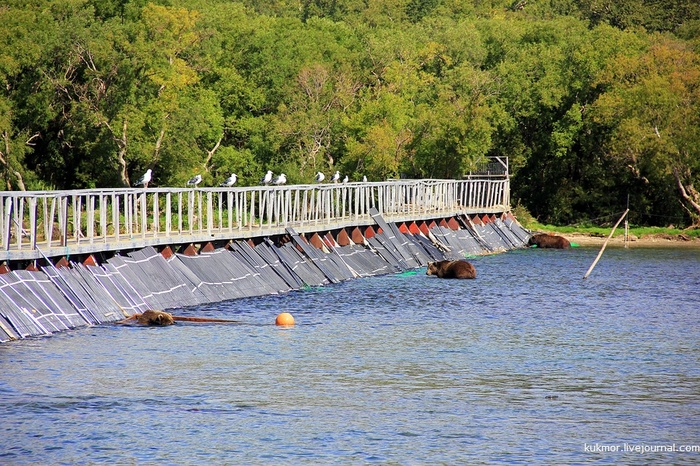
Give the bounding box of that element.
[0,248,700,464]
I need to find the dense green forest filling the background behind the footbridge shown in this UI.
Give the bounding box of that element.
[0,0,700,227]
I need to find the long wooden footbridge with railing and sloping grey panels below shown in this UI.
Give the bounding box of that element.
[0,176,529,341]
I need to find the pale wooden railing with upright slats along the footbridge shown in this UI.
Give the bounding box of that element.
[0,179,510,261]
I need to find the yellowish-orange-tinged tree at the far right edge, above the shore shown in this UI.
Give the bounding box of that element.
[592,37,700,224]
